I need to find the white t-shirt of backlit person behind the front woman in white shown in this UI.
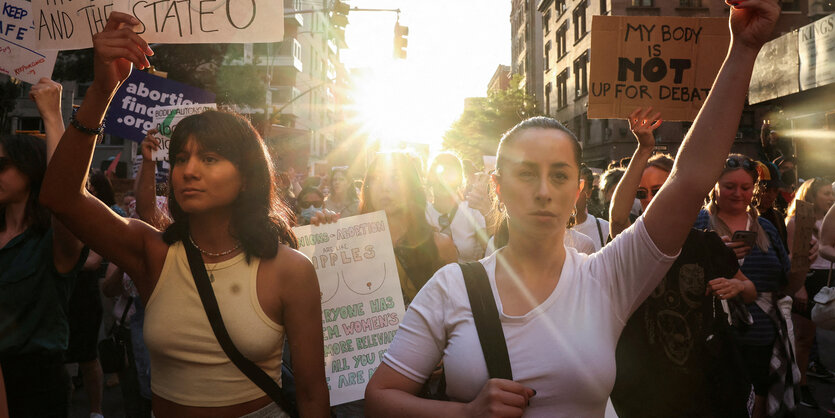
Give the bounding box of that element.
[426,201,487,263]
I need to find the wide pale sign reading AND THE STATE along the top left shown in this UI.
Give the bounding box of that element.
[32,0,284,49]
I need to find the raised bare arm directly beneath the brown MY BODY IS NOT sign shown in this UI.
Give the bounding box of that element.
[609,107,661,238]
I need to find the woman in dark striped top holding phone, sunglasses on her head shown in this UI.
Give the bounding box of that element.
[695,154,800,417]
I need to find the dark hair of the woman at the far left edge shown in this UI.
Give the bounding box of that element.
[0,135,51,233]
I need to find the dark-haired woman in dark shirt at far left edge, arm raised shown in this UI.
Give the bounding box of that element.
[0,79,88,418]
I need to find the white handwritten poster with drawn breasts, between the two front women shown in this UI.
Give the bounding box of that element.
[293,211,405,405]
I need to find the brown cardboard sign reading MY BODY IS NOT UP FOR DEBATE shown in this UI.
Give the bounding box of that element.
[588,16,730,121]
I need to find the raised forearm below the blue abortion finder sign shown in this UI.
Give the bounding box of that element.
[134,128,171,230]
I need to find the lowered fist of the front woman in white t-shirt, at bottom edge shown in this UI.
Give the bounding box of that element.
[467,379,536,417]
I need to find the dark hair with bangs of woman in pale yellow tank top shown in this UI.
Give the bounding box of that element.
[163,110,299,259]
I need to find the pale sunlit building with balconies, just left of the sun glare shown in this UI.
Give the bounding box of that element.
[224,0,348,174]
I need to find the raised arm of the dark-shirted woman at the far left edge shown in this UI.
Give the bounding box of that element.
[29,78,84,273]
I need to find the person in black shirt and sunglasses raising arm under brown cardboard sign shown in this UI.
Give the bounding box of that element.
[610,108,757,418]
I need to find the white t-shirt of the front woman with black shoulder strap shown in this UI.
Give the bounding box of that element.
[383,218,677,417]
